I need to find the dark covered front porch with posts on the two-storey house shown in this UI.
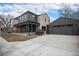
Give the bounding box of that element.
[14,21,39,33]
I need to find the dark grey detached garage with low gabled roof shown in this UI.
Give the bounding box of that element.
[47,17,79,35]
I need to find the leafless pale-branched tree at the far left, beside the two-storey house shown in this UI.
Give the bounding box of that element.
[0,14,13,32]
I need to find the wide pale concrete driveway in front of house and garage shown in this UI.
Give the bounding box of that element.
[0,35,79,56]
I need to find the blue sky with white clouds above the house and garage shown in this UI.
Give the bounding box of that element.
[0,3,71,21]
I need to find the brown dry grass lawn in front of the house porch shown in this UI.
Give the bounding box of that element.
[0,32,37,42]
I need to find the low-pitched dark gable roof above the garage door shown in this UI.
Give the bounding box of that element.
[49,17,79,25]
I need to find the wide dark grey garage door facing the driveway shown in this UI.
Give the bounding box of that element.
[52,26,72,34]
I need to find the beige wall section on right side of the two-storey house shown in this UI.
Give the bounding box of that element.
[37,14,50,29]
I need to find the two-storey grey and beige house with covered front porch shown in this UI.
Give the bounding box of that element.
[13,11,50,32]
